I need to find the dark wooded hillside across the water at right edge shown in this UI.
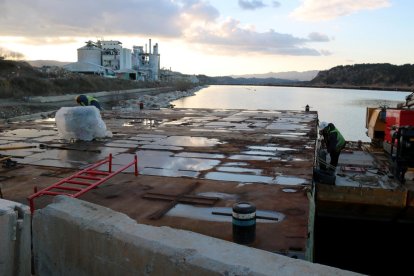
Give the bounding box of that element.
[310,63,414,90]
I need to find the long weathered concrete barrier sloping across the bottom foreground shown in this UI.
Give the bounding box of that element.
[33,196,355,276]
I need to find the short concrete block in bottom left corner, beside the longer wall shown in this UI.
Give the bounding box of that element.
[0,199,31,276]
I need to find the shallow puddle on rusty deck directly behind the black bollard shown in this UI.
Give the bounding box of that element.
[166,204,285,223]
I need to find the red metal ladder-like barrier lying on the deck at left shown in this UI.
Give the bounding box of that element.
[27,154,138,214]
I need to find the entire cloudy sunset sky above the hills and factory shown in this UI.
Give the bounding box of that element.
[0,0,414,76]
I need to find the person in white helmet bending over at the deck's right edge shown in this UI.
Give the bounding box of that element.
[319,122,346,167]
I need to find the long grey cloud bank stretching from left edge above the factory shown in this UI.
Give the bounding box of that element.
[0,0,330,56]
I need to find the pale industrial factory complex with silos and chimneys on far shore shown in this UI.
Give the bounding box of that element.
[64,39,160,81]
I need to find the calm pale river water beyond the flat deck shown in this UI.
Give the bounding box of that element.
[172,85,410,142]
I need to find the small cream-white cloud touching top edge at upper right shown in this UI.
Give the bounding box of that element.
[291,0,391,21]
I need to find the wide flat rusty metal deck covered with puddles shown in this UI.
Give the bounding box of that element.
[0,109,317,259]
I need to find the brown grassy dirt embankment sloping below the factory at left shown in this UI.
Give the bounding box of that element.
[0,60,197,119]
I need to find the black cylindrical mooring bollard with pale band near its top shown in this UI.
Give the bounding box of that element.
[232,202,256,244]
